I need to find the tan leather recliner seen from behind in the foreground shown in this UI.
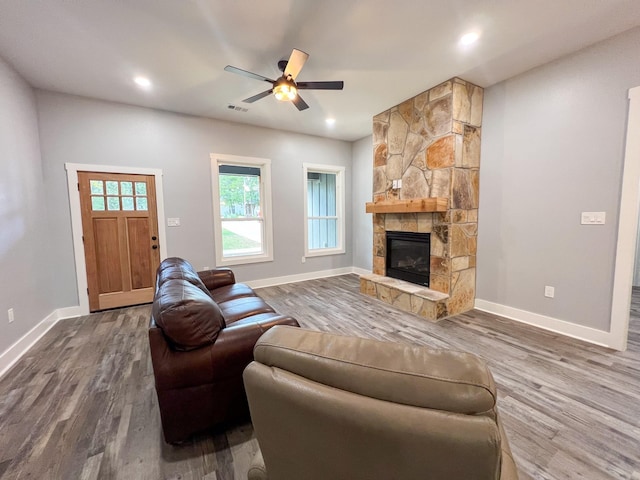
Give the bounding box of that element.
[244,327,518,480]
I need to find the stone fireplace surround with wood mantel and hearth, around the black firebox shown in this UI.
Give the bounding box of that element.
[360,78,483,320]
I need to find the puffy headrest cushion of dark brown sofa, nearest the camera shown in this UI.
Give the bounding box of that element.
[152,279,225,351]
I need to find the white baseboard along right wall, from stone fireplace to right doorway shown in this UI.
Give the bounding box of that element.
[475,298,620,350]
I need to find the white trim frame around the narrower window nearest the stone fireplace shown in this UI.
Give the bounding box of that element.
[302,163,345,257]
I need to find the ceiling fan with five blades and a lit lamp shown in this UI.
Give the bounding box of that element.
[224,48,344,110]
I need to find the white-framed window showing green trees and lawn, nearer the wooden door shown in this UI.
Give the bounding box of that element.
[211,154,273,265]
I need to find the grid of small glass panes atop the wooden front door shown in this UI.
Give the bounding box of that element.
[89,180,149,211]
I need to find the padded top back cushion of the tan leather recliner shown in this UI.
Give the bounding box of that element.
[254,327,496,416]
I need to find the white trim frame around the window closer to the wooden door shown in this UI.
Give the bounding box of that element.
[210,153,273,267]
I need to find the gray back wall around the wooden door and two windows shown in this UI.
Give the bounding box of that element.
[36,91,353,306]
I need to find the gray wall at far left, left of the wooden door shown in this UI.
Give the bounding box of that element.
[0,59,54,353]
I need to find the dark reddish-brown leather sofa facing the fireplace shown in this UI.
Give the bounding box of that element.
[149,257,298,443]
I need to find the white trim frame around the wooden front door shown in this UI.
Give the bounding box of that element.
[64,163,167,315]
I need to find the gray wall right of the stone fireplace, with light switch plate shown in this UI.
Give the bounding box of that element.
[477,28,640,330]
